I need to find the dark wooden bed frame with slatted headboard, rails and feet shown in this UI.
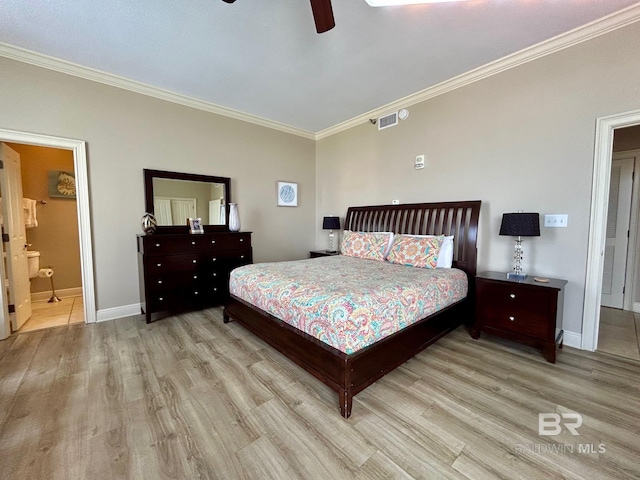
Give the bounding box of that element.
[224,201,480,418]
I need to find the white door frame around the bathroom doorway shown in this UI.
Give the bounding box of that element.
[0,128,96,338]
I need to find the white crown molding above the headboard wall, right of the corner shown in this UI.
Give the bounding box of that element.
[315,3,640,140]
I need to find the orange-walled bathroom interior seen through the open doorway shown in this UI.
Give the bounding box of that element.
[3,143,85,332]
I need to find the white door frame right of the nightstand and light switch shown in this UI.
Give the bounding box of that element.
[580,110,640,352]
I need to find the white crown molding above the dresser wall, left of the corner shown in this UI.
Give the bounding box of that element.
[0,42,315,140]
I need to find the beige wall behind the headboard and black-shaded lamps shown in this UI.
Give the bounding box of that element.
[316,23,640,333]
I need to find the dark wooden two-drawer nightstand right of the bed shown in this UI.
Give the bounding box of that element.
[471,272,567,363]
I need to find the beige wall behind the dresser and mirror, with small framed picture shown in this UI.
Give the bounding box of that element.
[0,58,315,310]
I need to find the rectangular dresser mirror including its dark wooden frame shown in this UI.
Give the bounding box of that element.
[144,169,231,233]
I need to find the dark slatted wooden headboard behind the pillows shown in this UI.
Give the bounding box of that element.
[344,200,481,278]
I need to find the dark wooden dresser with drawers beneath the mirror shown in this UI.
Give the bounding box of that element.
[137,232,253,323]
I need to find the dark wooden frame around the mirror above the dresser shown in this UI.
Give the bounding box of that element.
[143,168,231,235]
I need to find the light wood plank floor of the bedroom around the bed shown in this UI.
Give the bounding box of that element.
[0,309,640,480]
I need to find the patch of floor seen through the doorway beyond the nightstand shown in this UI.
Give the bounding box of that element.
[597,307,640,360]
